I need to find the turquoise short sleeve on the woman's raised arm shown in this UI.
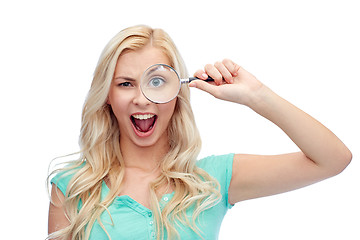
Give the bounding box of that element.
[196,153,234,209]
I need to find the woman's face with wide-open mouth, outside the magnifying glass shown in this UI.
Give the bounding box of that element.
[107,46,177,147]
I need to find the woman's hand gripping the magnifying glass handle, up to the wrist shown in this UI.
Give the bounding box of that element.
[189,59,263,106]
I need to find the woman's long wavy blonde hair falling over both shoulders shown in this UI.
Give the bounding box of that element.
[48,25,221,239]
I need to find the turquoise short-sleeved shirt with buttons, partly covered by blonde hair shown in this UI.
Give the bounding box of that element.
[51,154,234,240]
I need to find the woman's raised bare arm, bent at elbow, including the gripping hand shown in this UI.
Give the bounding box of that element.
[190,59,352,203]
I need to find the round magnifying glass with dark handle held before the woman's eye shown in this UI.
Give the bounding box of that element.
[140,64,214,103]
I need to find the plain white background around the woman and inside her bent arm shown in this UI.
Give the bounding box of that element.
[0,0,360,240]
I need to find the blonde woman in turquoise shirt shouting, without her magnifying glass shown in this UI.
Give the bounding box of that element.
[48,26,352,240]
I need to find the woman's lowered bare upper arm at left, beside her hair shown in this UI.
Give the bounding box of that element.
[48,184,70,237]
